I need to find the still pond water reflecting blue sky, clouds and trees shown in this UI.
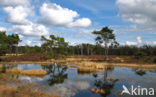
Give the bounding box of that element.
[3,63,156,97]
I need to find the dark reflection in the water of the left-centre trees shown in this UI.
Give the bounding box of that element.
[43,63,67,86]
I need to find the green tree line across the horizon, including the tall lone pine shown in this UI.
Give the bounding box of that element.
[0,27,156,60]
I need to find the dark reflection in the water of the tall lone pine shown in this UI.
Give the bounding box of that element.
[91,67,118,97]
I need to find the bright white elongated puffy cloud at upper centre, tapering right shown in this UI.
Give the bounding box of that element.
[38,3,91,27]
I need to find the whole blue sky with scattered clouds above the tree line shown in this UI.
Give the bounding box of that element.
[0,0,156,46]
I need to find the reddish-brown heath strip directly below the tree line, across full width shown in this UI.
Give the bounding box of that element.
[0,54,156,64]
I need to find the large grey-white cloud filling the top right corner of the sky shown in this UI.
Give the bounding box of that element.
[117,0,156,24]
